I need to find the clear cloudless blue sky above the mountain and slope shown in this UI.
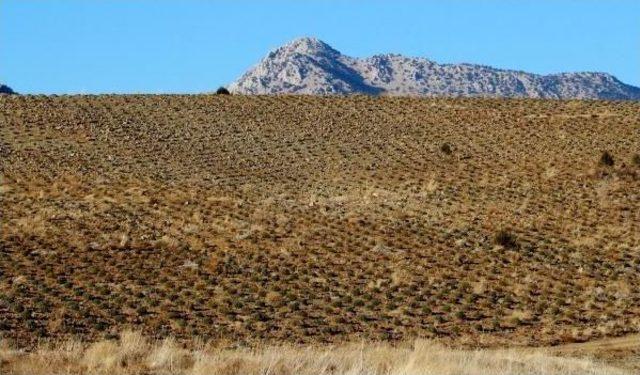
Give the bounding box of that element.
[0,0,640,93]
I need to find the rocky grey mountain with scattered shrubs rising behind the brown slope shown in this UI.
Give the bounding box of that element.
[229,38,640,100]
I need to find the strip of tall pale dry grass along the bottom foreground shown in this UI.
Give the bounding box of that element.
[0,332,631,375]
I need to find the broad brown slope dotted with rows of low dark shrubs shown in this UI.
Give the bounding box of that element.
[0,96,640,346]
